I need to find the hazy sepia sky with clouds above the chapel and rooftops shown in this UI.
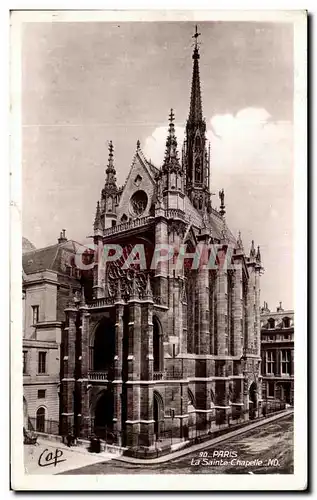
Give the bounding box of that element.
[22,22,294,310]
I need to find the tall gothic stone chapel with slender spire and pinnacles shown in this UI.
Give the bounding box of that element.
[60,28,262,454]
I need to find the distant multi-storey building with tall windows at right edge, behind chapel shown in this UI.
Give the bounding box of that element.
[261,302,294,406]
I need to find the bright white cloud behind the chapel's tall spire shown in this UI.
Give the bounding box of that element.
[144,108,293,174]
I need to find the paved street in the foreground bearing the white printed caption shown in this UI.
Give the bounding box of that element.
[64,415,293,474]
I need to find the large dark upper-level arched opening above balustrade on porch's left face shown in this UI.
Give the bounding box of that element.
[92,318,116,376]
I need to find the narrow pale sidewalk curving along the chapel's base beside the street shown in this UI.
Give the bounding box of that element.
[115,409,293,465]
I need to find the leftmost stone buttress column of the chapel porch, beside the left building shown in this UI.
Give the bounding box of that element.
[61,305,77,436]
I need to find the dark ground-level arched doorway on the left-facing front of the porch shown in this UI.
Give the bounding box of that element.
[94,389,114,442]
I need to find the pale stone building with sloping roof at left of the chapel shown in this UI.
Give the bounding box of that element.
[22,231,81,434]
